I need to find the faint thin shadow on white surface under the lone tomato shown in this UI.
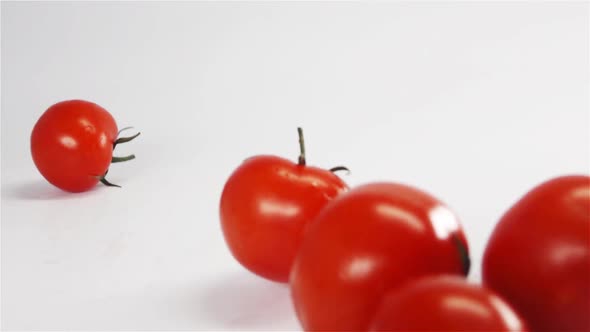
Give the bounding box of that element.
[2,179,97,201]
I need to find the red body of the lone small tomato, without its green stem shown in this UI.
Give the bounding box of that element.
[31,100,117,192]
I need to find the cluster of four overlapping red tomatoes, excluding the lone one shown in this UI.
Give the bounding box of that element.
[220,129,590,332]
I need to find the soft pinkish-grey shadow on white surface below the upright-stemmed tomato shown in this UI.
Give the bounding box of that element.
[198,271,296,331]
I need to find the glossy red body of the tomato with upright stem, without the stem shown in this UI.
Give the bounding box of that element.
[220,156,348,282]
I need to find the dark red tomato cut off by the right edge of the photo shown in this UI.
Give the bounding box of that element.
[482,176,590,331]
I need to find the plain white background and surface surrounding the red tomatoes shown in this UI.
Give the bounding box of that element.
[1,2,590,330]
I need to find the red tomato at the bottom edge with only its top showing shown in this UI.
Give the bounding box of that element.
[369,276,526,332]
